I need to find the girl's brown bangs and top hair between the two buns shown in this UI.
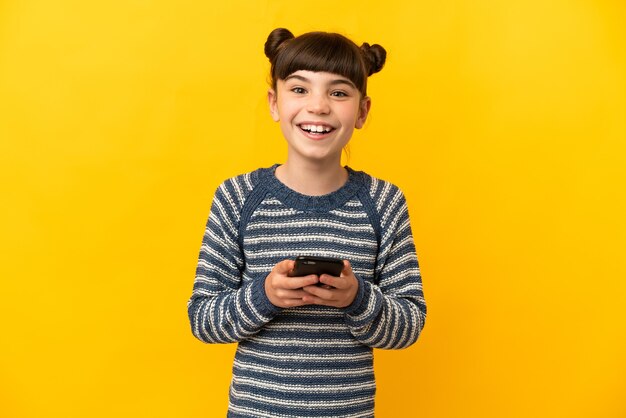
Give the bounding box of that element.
[272,32,367,96]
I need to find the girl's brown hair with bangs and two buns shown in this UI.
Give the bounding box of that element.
[265,28,387,97]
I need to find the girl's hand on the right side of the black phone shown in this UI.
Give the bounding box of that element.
[302,260,359,308]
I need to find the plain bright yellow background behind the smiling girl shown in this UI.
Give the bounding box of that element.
[0,0,626,418]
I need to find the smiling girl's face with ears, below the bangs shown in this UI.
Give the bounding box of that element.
[268,70,370,163]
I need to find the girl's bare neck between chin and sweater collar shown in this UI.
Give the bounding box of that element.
[276,159,348,196]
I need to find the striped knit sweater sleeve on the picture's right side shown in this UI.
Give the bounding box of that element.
[346,183,426,349]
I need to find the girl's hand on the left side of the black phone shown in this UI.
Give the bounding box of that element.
[265,260,319,308]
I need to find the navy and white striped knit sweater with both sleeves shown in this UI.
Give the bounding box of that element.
[188,165,426,418]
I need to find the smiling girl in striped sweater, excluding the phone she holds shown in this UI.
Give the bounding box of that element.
[188,29,426,418]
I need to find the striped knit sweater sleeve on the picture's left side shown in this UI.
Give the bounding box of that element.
[187,178,278,343]
